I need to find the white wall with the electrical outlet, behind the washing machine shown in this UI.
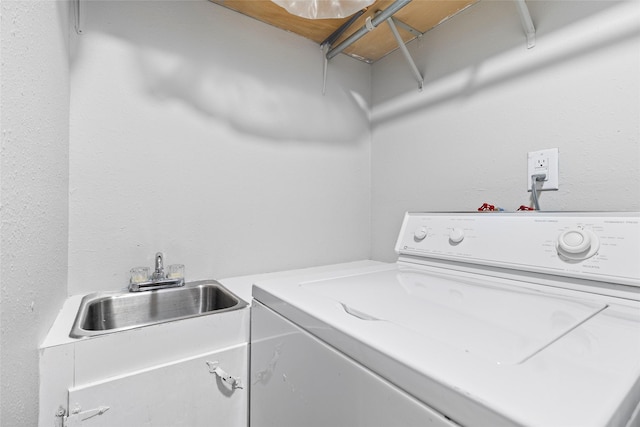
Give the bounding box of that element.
[371,0,640,260]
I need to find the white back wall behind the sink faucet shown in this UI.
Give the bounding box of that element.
[69,0,370,294]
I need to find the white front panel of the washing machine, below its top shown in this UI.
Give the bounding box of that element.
[250,302,455,427]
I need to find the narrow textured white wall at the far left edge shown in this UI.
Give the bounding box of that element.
[0,0,69,426]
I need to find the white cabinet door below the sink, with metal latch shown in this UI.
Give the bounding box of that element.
[68,344,248,427]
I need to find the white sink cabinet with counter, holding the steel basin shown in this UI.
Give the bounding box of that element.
[39,296,249,427]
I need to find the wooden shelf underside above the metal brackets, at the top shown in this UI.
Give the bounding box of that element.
[210,0,478,62]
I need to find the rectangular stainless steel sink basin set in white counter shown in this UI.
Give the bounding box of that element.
[69,280,248,338]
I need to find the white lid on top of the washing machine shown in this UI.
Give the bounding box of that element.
[301,268,607,364]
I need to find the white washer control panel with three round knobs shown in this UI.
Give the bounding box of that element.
[396,212,640,286]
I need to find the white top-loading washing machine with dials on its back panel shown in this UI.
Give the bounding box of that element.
[250,212,640,427]
